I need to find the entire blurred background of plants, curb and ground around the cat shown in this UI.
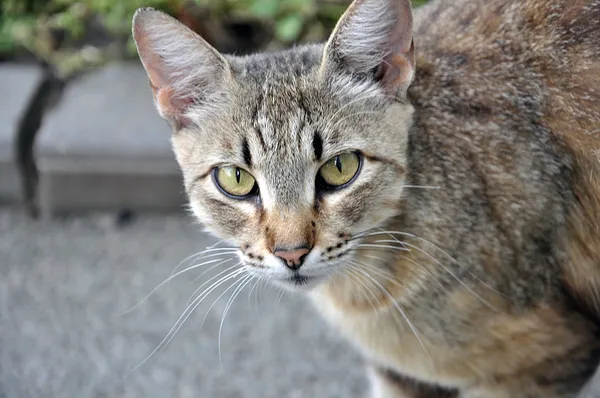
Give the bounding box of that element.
[0,0,423,398]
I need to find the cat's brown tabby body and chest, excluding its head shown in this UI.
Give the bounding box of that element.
[317,0,600,397]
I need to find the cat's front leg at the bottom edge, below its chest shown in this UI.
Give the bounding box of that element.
[369,367,458,398]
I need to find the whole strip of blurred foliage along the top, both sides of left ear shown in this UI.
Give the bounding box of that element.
[0,0,426,76]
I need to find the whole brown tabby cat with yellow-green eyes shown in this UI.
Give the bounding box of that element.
[133,0,600,398]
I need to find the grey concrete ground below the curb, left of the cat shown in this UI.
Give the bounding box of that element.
[0,208,367,398]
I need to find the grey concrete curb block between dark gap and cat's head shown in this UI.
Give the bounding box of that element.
[36,63,185,216]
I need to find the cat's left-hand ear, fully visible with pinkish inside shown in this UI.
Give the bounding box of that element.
[133,8,229,126]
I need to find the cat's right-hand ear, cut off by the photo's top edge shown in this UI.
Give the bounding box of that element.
[323,0,415,95]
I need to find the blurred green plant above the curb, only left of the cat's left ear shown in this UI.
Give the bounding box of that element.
[0,0,181,76]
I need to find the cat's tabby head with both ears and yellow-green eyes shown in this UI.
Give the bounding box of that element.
[133,0,414,287]
